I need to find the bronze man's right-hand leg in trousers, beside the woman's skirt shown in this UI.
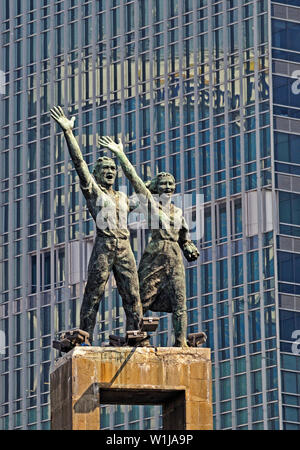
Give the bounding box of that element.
[113,239,143,331]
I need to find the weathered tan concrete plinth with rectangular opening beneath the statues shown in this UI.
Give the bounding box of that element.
[50,347,213,430]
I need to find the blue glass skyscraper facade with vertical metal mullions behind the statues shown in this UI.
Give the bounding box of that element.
[0,0,300,429]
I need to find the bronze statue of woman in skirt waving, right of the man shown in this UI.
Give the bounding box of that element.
[98,137,199,347]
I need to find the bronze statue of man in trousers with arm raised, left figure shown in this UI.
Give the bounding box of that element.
[50,106,143,342]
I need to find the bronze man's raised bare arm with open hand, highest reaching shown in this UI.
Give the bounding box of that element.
[50,106,93,187]
